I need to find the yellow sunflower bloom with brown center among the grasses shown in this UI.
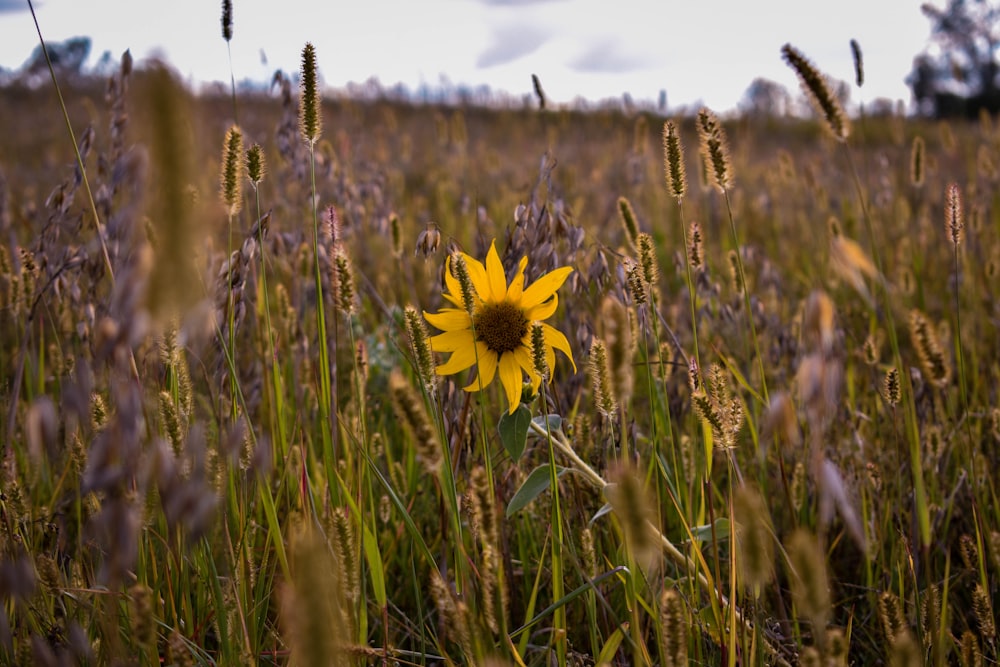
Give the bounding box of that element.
[424,241,576,414]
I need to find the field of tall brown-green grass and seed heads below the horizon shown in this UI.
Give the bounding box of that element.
[0,34,1000,666]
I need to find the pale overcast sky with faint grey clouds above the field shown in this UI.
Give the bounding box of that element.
[0,0,932,112]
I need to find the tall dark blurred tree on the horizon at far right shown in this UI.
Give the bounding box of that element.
[906,0,1000,117]
